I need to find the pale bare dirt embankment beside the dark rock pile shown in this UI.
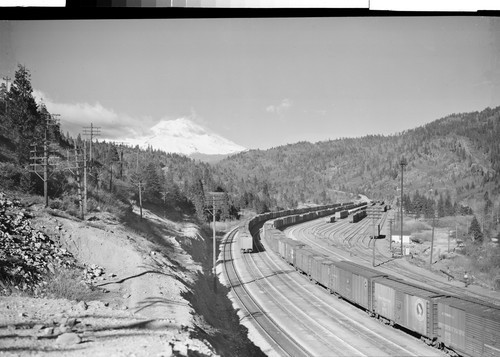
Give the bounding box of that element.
[0,200,221,356]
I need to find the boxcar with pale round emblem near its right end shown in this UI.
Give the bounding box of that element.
[372,278,441,338]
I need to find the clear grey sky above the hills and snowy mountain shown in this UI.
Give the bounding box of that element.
[0,16,500,149]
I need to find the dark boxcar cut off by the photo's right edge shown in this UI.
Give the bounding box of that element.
[436,297,500,357]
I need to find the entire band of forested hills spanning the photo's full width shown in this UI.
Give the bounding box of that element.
[0,65,500,242]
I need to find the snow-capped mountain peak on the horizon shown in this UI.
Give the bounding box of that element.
[122,118,246,155]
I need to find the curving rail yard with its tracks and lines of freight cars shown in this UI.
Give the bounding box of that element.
[221,202,500,357]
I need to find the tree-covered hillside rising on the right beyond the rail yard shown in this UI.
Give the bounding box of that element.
[214,107,500,236]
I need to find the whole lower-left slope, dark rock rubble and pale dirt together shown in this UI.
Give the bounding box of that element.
[0,193,217,356]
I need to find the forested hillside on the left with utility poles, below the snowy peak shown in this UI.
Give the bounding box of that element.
[0,65,237,220]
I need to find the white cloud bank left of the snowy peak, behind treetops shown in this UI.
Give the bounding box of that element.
[33,90,154,140]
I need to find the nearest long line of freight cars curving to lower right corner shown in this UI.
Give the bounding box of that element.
[239,206,500,357]
